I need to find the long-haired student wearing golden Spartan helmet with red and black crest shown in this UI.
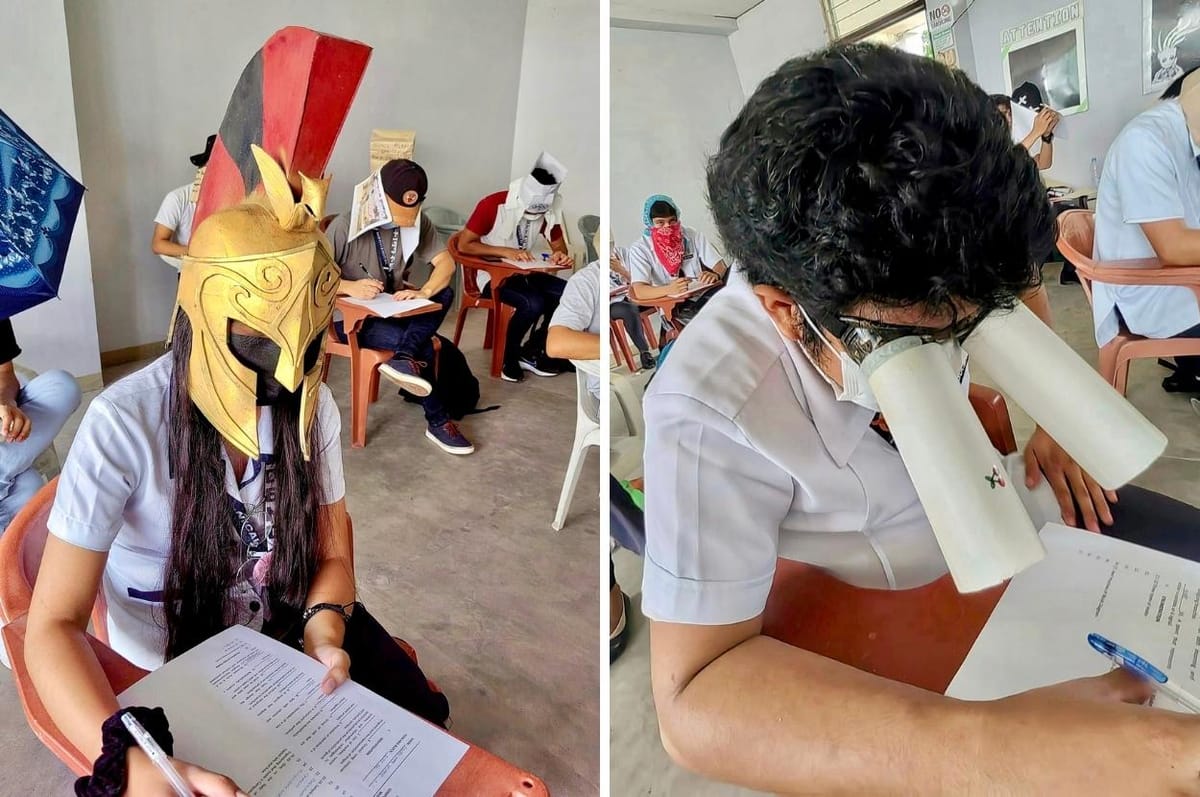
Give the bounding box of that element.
[25,28,449,796]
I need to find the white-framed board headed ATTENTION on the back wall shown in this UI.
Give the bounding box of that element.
[1001,0,1089,116]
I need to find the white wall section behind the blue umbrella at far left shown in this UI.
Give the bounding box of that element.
[0,0,100,377]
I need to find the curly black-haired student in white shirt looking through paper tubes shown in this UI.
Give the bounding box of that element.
[642,44,1200,795]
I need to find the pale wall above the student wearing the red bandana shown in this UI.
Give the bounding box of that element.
[610,28,745,246]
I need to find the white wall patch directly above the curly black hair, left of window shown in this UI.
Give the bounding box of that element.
[730,0,829,97]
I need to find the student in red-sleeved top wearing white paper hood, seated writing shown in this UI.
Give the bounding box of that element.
[458,152,575,382]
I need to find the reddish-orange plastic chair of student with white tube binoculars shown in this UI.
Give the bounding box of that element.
[762,384,1016,693]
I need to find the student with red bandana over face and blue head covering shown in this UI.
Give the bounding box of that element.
[626,193,730,323]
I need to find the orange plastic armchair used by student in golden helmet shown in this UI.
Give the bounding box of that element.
[0,479,550,797]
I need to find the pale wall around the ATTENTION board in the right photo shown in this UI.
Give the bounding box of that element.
[954,0,1156,186]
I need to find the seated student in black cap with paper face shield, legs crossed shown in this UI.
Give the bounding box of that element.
[326,160,475,456]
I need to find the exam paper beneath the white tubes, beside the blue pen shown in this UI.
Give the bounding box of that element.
[946,523,1200,711]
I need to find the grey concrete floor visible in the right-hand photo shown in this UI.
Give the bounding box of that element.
[610,265,1200,797]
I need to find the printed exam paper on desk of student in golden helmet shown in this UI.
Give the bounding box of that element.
[118,625,467,797]
